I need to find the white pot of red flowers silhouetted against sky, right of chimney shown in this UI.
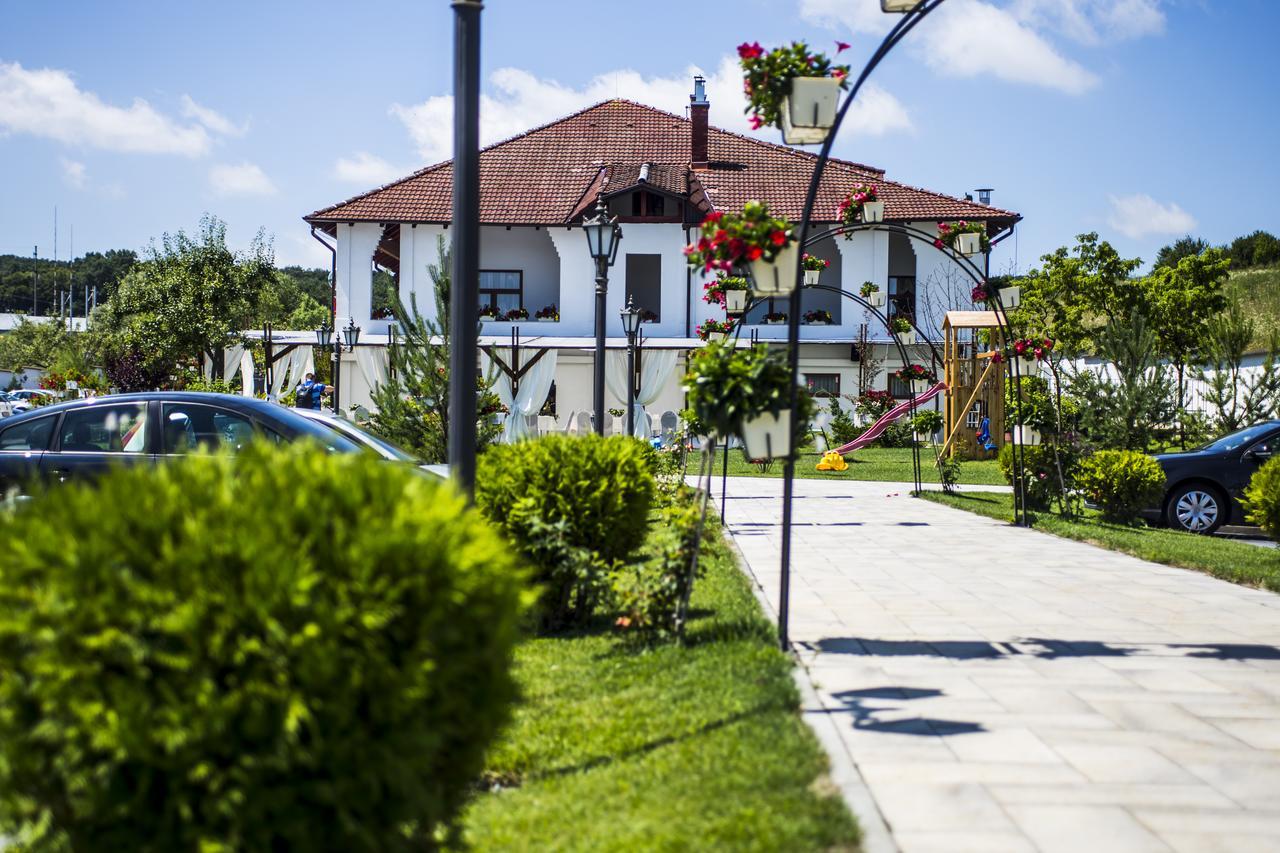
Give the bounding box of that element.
[737,41,849,145]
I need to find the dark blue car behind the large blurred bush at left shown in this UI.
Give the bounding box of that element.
[0,391,366,497]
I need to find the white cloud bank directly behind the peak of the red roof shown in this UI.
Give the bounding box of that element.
[390,56,911,163]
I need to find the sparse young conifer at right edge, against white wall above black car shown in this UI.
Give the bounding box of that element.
[1196,300,1280,433]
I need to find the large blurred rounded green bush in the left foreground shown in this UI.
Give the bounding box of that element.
[0,444,529,850]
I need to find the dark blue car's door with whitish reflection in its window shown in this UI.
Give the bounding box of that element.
[40,402,152,483]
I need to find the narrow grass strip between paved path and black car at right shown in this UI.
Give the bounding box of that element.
[922,492,1280,592]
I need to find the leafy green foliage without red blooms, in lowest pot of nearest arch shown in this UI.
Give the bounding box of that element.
[685,343,813,437]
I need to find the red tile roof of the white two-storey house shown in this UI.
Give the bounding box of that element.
[306,100,1020,225]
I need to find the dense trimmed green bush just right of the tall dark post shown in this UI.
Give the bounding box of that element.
[476,435,658,626]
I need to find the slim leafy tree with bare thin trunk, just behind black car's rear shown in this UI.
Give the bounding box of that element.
[1144,241,1231,448]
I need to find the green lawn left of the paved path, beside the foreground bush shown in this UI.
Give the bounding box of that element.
[463,526,858,850]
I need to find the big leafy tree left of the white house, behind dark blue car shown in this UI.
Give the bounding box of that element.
[95,214,275,387]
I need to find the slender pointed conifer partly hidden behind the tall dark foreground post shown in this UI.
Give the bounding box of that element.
[369,237,500,462]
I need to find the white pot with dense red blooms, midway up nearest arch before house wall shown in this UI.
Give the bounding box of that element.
[685,201,800,296]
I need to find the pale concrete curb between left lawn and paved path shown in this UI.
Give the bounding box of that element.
[723,526,900,853]
